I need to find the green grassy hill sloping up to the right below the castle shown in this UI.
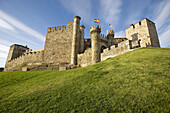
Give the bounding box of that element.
[0,48,170,113]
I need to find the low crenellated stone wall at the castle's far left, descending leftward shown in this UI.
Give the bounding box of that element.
[5,51,44,71]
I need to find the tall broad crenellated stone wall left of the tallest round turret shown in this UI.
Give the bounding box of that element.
[44,21,73,63]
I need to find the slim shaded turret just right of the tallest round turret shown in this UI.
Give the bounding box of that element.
[79,25,85,53]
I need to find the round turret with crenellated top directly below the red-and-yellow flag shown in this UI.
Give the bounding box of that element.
[90,25,101,64]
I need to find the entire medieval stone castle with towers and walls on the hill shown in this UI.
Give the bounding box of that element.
[4,16,160,71]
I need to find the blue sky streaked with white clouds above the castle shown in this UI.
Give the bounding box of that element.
[0,0,170,67]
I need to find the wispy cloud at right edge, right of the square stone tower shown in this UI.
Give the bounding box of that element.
[152,0,170,47]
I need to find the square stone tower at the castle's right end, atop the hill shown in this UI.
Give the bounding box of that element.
[126,18,160,47]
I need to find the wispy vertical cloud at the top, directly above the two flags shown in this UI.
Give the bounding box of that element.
[97,0,122,34]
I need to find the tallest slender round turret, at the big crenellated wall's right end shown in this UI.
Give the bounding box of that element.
[71,16,81,65]
